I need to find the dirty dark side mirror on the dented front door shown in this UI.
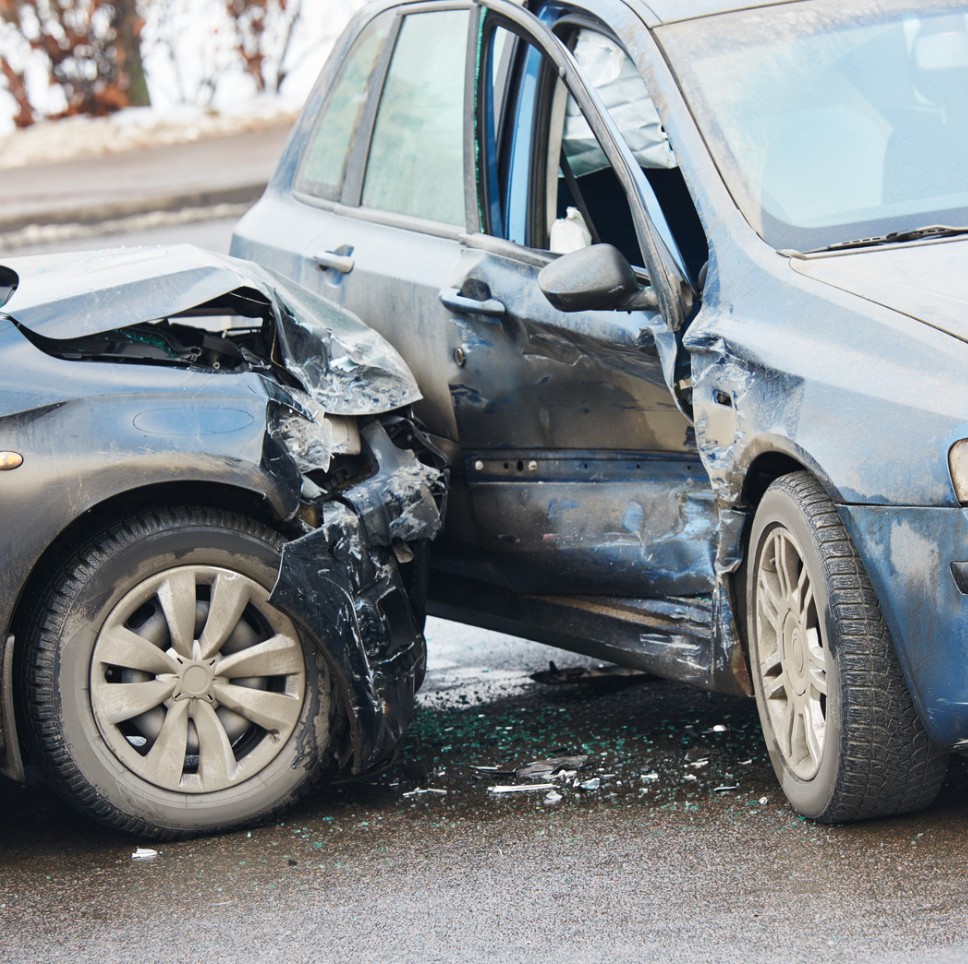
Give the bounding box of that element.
[538,244,658,311]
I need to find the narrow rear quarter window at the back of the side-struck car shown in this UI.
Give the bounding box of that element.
[296,13,394,200]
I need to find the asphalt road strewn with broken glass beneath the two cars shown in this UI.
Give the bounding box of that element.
[0,222,968,962]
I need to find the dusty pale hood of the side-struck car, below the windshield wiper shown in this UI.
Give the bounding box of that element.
[790,238,968,341]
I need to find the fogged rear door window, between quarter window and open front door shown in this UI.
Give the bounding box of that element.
[362,10,469,225]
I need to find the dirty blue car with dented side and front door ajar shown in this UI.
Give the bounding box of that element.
[233,0,968,821]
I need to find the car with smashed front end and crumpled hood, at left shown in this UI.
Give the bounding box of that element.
[0,246,444,836]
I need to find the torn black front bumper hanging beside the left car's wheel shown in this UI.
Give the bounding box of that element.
[270,421,446,773]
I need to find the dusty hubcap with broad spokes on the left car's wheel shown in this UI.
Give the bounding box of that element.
[91,566,306,793]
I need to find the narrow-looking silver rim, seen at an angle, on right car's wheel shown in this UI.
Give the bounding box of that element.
[756,526,827,780]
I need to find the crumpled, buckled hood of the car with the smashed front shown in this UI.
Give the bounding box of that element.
[0,244,421,415]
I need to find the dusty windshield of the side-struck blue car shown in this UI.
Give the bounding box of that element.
[659,0,968,251]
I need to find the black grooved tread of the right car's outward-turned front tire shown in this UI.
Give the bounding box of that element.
[771,472,948,823]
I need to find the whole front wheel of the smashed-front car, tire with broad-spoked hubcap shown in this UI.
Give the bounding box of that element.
[22,507,331,839]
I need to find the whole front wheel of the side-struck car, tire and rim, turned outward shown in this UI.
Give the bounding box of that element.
[747,472,947,823]
